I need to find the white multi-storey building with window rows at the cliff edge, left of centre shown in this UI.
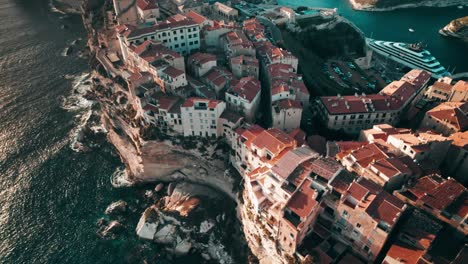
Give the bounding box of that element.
[181,97,226,138]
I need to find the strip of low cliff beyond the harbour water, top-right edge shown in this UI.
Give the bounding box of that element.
[350,0,466,11]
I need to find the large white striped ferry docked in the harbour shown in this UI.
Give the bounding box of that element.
[366,38,450,79]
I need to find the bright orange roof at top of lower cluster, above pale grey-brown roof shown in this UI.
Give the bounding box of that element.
[252,128,296,156]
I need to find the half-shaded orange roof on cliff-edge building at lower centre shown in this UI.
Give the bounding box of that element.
[286,179,318,218]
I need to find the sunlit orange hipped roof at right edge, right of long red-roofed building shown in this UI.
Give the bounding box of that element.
[426,102,468,131]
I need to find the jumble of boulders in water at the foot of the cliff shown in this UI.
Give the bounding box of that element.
[136,182,246,263]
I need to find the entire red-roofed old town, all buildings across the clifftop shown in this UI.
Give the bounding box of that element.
[108,0,468,264]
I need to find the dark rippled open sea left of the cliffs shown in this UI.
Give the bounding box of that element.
[0,0,145,263]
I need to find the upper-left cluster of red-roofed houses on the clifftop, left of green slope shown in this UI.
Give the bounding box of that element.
[116,0,309,140]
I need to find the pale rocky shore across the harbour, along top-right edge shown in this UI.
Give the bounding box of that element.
[349,0,466,12]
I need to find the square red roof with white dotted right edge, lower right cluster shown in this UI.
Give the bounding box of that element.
[366,191,405,226]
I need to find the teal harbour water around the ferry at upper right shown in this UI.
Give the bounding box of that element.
[278,0,468,72]
